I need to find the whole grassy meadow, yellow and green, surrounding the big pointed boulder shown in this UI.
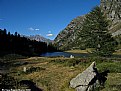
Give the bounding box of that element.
[5,57,121,91]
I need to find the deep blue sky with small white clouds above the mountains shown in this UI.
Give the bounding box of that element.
[0,0,100,40]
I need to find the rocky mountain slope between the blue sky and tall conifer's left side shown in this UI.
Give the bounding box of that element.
[54,16,84,50]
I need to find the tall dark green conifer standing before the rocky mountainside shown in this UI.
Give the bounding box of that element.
[80,6,116,56]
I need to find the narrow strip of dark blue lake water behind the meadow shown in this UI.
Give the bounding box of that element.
[40,52,89,57]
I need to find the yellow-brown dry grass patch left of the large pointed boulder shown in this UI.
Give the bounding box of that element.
[11,58,86,91]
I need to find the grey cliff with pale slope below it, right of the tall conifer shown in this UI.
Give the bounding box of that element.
[100,0,121,36]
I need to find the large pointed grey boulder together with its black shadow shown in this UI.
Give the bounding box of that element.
[70,62,109,91]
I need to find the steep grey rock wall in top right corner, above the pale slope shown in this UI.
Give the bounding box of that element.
[100,0,121,23]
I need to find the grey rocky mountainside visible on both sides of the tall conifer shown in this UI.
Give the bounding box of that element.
[54,0,121,50]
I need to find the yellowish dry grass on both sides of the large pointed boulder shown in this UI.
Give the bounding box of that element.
[11,57,121,91]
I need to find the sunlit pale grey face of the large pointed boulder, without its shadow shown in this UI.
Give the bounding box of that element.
[70,62,96,91]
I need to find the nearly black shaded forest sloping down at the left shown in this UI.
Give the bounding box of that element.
[0,29,57,56]
